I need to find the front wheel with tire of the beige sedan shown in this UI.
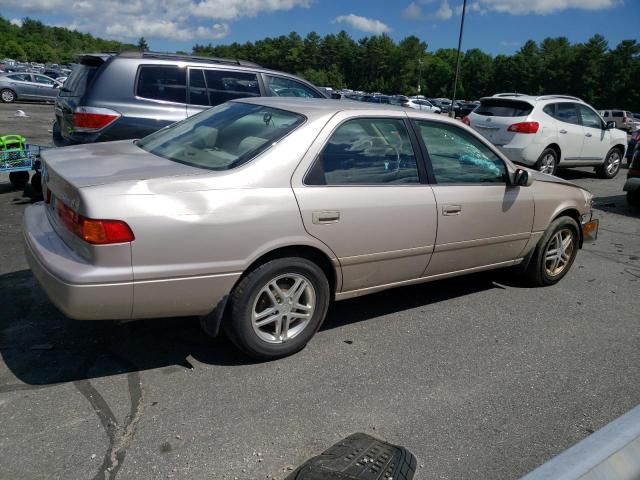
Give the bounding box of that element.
[526,217,580,286]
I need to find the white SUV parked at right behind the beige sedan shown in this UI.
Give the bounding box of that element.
[463,94,627,178]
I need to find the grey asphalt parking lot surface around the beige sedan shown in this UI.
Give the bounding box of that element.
[0,104,640,480]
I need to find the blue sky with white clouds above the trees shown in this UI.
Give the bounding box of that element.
[0,0,640,55]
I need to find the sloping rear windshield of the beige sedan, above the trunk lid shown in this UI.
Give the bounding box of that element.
[137,102,305,170]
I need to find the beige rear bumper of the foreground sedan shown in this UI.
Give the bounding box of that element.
[23,204,241,320]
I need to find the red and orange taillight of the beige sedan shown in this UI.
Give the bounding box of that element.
[56,199,135,245]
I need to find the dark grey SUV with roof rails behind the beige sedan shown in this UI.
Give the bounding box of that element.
[53,52,327,146]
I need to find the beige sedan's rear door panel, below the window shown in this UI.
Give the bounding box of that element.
[294,185,437,291]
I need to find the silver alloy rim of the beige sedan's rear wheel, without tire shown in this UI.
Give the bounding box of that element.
[251,273,316,343]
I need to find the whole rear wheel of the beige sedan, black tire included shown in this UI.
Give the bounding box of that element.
[223,257,330,360]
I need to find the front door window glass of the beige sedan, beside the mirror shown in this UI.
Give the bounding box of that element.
[417,121,507,184]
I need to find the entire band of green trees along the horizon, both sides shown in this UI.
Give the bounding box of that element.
[0,16,640,111]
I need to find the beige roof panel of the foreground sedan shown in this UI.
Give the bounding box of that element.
[233,97,461,126]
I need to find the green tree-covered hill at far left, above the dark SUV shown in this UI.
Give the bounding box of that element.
[0,16,136,64]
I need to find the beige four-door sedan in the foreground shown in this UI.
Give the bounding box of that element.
[24,98,598,359]
